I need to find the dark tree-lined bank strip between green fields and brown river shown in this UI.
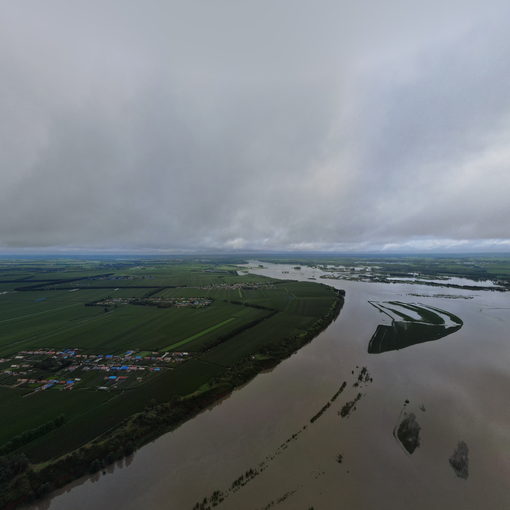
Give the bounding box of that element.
[0,290,345,510]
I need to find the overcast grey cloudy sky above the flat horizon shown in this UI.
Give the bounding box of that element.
[0,0,510,252]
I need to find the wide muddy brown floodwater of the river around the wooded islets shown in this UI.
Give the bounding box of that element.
[30,264,510,510]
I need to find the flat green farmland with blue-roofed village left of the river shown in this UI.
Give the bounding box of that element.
[0,258,339,463]
